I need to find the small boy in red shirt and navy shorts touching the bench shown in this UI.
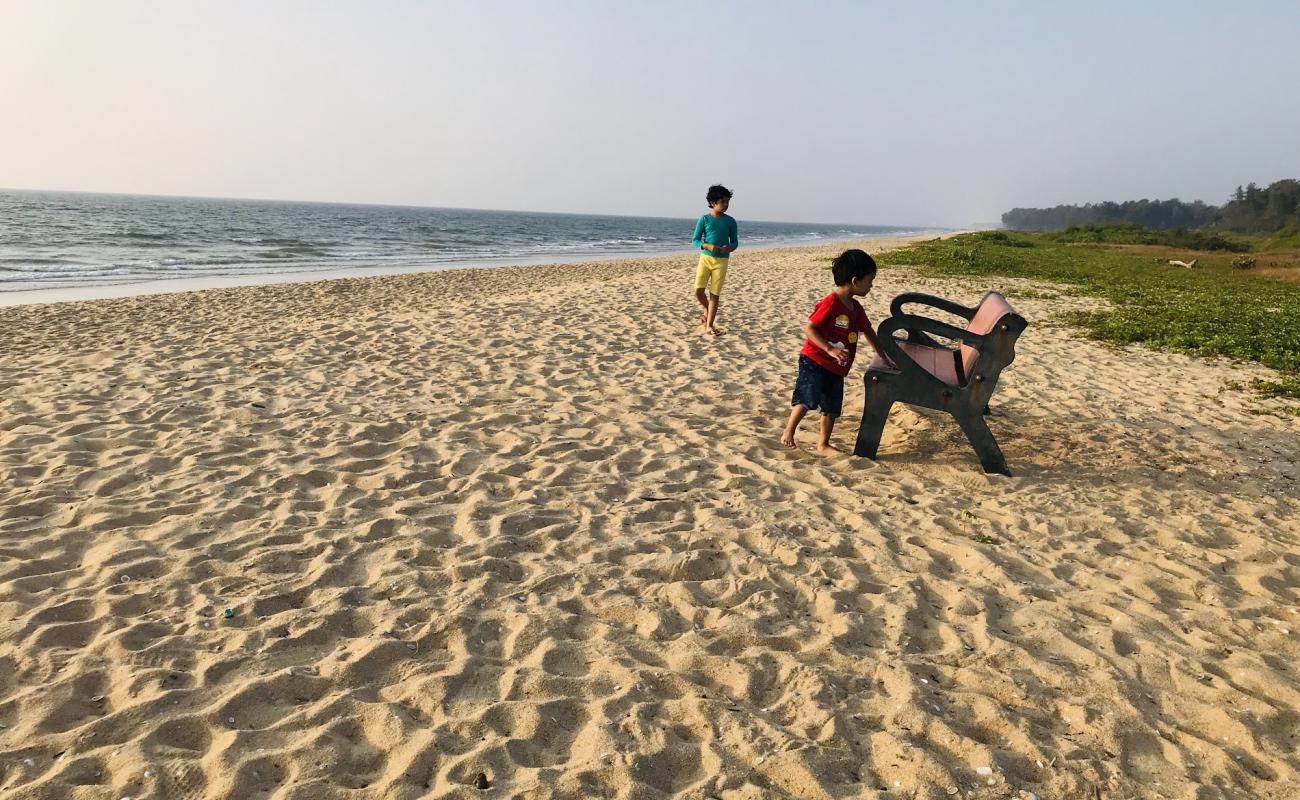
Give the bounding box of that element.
[781,250,889,453]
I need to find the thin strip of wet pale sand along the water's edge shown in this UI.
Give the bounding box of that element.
[0,230,963,308]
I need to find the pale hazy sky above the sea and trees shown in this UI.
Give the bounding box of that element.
[0,0,1300,225]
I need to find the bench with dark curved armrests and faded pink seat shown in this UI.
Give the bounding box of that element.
[853,291,1028,475]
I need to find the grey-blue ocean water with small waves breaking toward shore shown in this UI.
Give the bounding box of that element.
[0,190,920,299]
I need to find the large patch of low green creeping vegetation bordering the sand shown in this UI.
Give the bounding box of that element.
[880,230,1300,398]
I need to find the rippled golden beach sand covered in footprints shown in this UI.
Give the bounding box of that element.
[0,241,1300,800]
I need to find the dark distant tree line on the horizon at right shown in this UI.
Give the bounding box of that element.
[1002,178,1300,233]
